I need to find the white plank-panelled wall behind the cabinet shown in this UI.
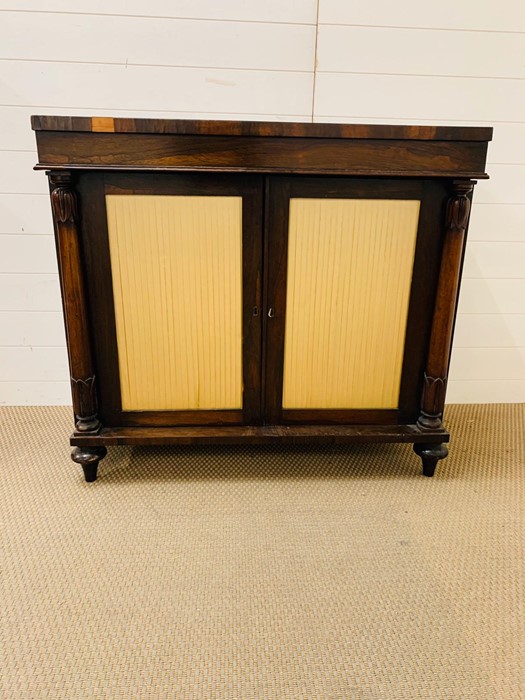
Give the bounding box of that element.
[0,0,525,404]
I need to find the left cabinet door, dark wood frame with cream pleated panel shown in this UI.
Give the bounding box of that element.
[79,173,262,426]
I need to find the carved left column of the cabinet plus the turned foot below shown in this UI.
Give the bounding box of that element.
[48,171,105,481]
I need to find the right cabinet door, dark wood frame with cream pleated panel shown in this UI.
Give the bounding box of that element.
[264,178,445,424]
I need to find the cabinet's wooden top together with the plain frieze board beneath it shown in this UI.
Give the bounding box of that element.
[31,116,492,178]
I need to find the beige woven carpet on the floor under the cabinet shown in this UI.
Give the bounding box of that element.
[0,405,525,700]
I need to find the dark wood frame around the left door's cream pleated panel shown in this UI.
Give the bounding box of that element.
[78,173,263,427]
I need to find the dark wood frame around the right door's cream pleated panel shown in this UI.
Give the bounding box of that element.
[263,177,447,425]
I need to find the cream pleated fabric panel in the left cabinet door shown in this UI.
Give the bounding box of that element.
[106,195,242,411]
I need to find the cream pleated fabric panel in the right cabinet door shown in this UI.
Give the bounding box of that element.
[283,199,420,409]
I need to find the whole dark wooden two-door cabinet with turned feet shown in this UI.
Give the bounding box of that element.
[32,117,492,481]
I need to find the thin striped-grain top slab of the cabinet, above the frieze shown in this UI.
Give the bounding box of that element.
[31,116,492,141]
